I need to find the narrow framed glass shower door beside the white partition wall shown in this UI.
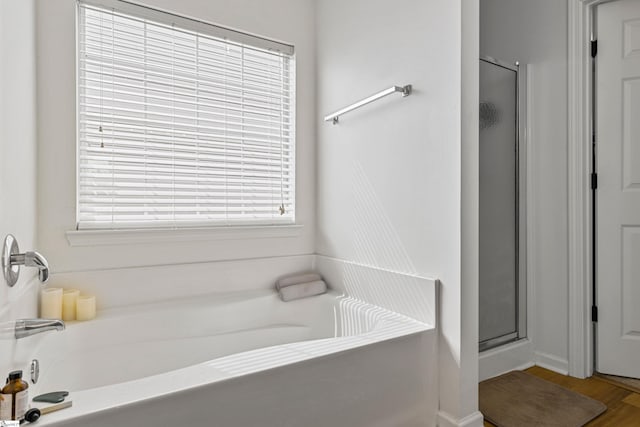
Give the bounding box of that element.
[479,57,526,351]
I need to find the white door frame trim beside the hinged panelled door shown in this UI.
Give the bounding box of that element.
[567,0,616,378]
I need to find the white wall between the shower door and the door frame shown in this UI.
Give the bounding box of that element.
[480,0,568,371]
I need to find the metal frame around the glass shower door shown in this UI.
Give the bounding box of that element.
[478,55,529,352]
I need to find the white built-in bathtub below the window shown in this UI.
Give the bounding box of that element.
[19,291,437,427]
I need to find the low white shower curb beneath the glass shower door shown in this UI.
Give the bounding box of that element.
[478,339,535,381]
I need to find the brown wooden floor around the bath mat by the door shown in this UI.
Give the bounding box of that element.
[484,366,640,427]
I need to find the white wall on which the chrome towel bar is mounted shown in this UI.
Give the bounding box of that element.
[316,0,481,425]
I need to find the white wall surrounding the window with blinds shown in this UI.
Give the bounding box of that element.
[37,0,316,273]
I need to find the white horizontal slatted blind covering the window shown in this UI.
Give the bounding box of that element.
[77,2,295,229]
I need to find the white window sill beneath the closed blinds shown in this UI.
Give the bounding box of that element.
[66,225,303,246]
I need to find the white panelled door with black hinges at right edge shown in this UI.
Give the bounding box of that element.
[596,0,640,378]
